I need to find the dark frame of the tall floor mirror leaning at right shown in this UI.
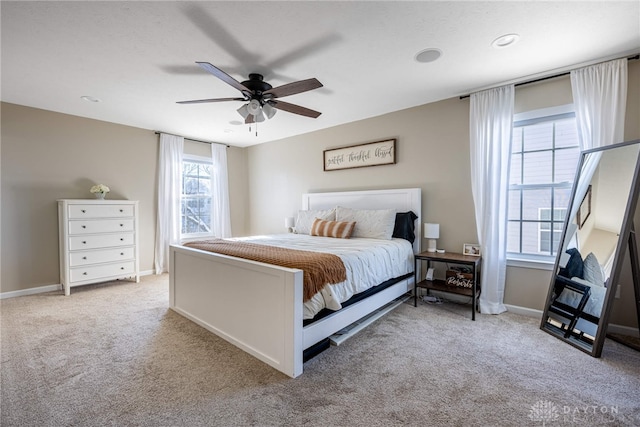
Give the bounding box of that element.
[540,139,640,357]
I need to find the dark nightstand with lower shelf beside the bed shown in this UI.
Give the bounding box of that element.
[413,252,482,320]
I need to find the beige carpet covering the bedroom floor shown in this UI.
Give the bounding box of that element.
[0,276,640,427]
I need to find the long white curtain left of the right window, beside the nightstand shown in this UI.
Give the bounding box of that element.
[469,85,515,314]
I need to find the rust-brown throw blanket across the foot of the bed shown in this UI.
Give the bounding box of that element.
[184,239,347,302]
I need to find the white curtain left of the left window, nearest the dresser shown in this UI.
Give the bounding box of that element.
[155,133,184,274]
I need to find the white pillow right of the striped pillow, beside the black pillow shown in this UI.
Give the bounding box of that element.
[336,206,396,240]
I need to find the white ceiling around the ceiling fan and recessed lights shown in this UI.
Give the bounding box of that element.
[0,1,640,146]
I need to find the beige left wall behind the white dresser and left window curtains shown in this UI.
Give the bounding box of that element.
[0,103,247,293]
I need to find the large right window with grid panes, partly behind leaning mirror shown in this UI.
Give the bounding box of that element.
[507,106,580,259]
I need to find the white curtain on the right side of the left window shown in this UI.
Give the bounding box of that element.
[211,144,231,238]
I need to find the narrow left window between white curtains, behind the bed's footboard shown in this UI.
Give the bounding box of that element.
[181,156,213,237]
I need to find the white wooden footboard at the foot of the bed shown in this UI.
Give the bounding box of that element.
[169,246,304,377]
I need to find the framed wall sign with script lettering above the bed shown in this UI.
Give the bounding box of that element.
[323,139,396,171]
